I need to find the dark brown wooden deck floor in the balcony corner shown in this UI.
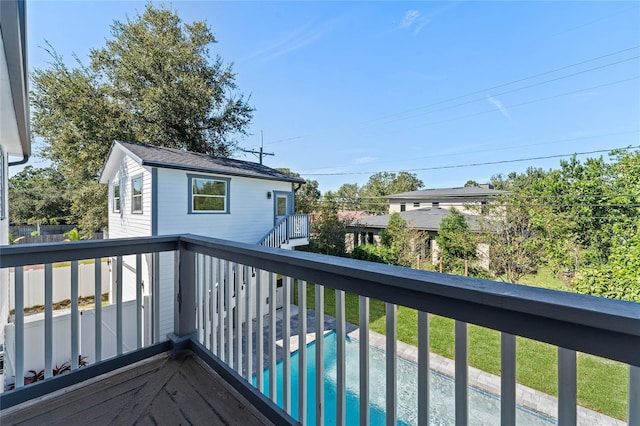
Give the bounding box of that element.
[0,355,271,426]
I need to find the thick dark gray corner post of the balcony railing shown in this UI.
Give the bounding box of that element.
[174,247,196,337]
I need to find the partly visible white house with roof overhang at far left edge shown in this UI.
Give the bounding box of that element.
[0,0,31,392]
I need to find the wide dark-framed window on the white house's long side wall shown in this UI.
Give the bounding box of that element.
[189,175,229,213]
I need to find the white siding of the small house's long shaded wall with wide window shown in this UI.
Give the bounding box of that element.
[157,169,292,244]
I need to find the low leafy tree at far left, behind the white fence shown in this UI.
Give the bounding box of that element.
[9,166,72,225]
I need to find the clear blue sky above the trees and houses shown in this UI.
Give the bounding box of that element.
[22,0,640,191]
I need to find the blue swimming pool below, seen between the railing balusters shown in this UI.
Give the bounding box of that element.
[253,332,556,426]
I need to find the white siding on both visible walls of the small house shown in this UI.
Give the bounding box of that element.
[102,150,293,339]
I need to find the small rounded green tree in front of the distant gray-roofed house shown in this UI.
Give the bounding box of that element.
[436,208,477,272]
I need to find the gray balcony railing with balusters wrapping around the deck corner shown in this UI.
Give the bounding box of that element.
[0,235,640,425]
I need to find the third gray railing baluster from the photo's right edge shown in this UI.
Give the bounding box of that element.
[500,333,516,426]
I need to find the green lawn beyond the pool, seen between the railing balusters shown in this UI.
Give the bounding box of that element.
[294,278,628,420]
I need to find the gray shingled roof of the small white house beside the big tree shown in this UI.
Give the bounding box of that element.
[111,141,305,183]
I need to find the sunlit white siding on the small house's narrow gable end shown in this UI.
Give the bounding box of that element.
[108,156,151,238]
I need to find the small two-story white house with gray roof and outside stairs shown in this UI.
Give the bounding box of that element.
[100,141,309,342]
